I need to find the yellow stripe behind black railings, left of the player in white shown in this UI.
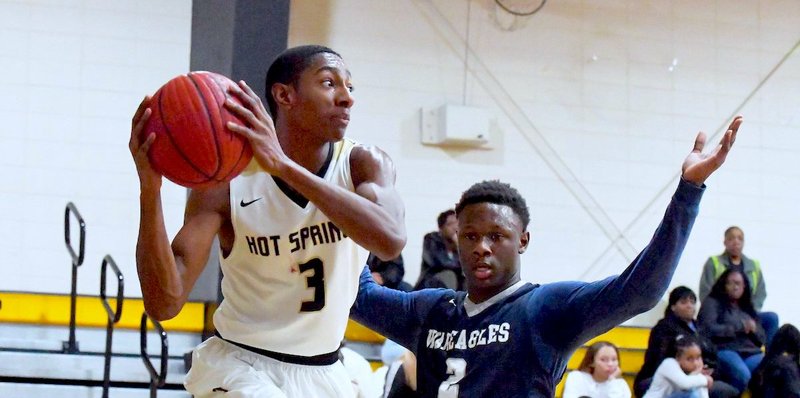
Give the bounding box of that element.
[0,292,204,332]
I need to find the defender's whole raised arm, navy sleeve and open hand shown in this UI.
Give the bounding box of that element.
[556,116,742,345]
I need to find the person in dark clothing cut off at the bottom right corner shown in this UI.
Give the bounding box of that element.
[750,324,800,398]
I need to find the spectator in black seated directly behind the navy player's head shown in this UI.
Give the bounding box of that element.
[414,209,464,290]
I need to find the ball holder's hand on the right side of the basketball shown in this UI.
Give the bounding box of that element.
[225,81,289,175]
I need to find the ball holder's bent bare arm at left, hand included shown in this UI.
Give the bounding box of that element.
[128,96,227,320]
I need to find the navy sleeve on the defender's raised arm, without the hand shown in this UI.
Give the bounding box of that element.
[534,179,705,349]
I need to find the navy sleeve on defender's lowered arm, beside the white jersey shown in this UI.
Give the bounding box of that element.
[350,267,455,352]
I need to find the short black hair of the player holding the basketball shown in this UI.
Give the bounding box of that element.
[264,45,342,119]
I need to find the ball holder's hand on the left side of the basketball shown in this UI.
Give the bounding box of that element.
[128,95,161,188]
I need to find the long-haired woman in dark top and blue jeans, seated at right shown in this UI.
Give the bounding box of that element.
[697,268,765,392]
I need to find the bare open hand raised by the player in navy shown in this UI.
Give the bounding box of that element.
[683,116,742,185]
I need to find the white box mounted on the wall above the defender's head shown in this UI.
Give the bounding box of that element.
[420,105,490,148]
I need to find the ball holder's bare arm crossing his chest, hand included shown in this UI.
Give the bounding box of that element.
[225,82,406,260]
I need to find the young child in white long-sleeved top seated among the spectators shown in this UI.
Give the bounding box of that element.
[644,335,714,398]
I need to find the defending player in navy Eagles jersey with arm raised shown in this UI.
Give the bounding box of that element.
[351,117,742,398]
